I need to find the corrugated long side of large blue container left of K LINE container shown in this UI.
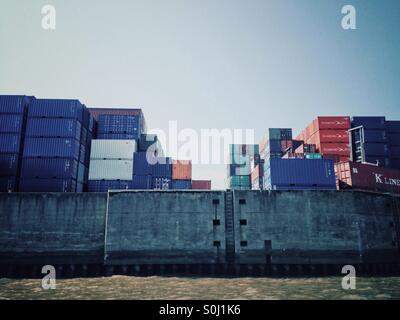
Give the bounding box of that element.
[270,159,336,188]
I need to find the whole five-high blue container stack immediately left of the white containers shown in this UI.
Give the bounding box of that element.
[20,99,93,192]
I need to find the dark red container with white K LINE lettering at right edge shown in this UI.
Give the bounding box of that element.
[335,162,400,194]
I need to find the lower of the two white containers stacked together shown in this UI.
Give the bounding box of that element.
[89,160,133,180]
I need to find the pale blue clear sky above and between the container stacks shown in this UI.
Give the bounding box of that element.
[0,0,400,189]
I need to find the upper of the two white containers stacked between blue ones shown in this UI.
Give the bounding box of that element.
[90,140,137,160]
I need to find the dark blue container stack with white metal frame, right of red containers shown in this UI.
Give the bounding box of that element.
[350,117,390,167]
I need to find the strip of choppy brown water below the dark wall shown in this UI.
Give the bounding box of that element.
[0,276,400,300]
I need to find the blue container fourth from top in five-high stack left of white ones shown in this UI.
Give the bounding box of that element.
[21,158,78,179]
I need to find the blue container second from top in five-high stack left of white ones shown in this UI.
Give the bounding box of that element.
[25,118,81,140]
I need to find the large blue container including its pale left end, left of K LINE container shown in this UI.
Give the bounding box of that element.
[264,158,336,190]
